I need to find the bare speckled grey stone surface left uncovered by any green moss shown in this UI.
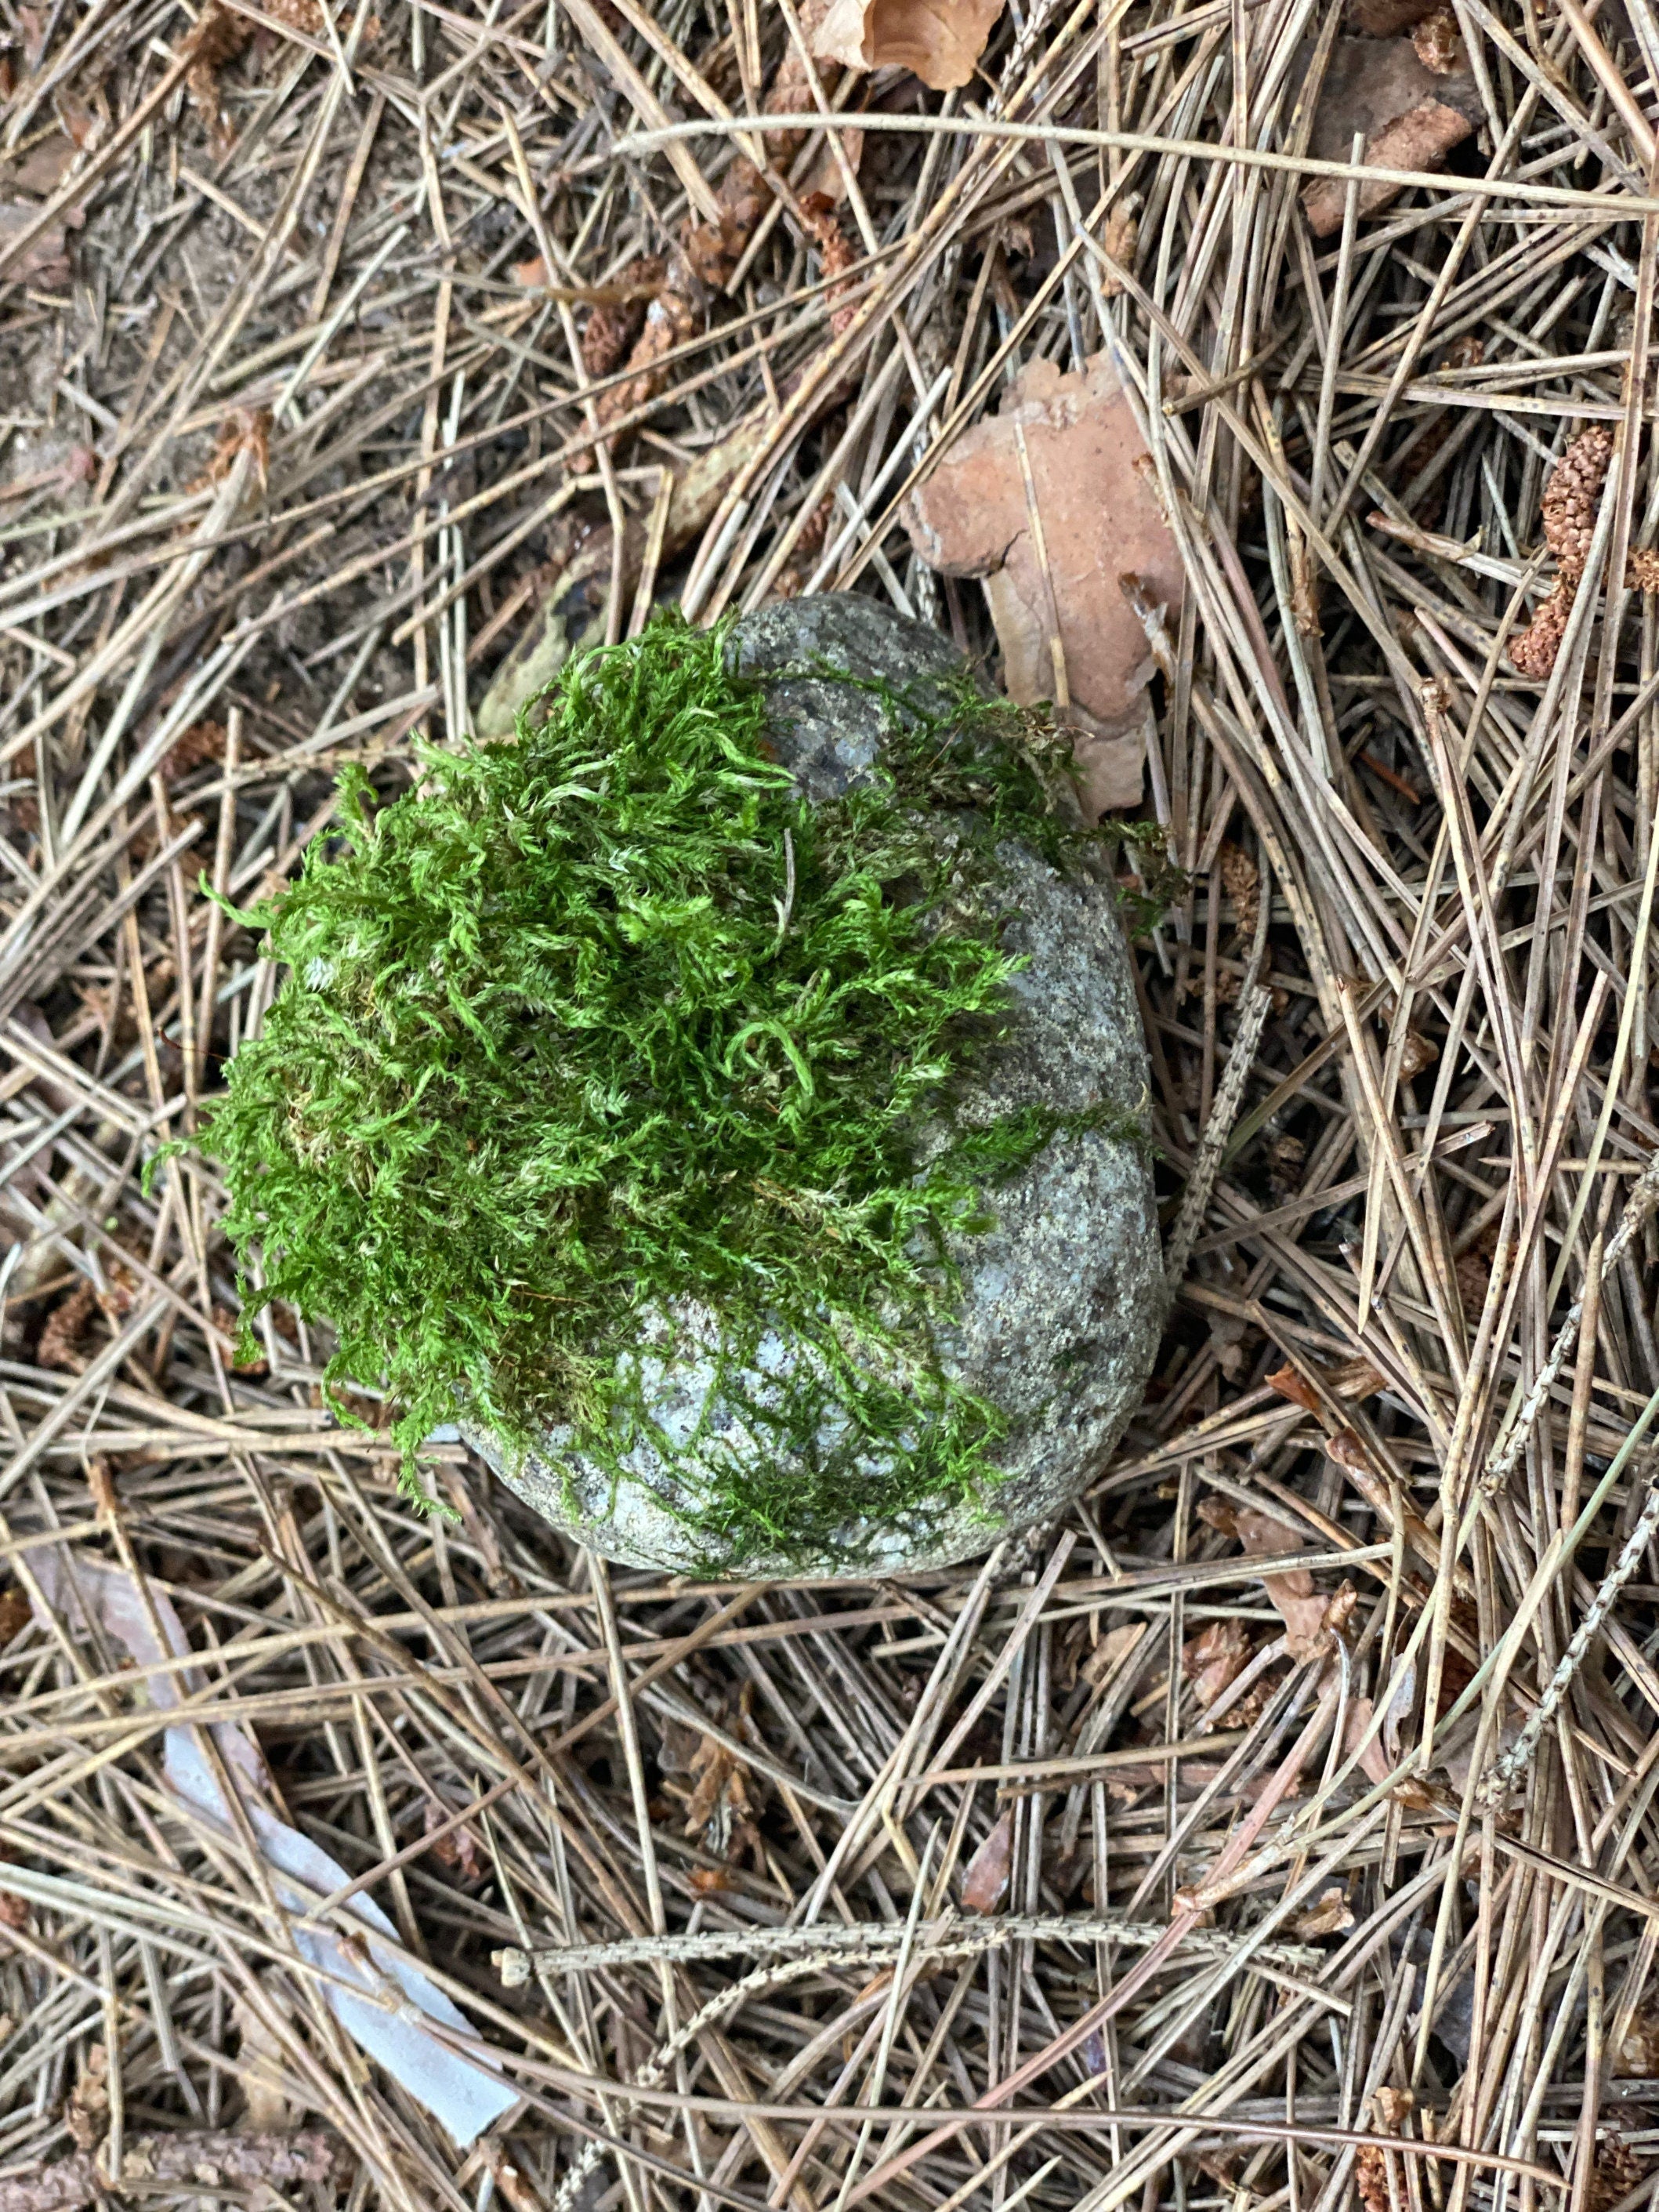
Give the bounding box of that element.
[471,595,1164,1579]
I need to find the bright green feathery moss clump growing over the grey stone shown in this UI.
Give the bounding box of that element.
[206,619,1106,1560]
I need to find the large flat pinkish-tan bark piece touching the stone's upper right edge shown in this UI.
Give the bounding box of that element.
[903,354,1183,821]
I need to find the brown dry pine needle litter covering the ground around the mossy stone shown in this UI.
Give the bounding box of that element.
[0,13,1659,2212]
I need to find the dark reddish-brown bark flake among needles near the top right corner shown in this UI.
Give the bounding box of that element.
[1303,38,1480,239]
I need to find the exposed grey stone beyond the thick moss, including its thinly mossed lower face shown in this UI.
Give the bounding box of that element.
[465,597,1166,1577]
